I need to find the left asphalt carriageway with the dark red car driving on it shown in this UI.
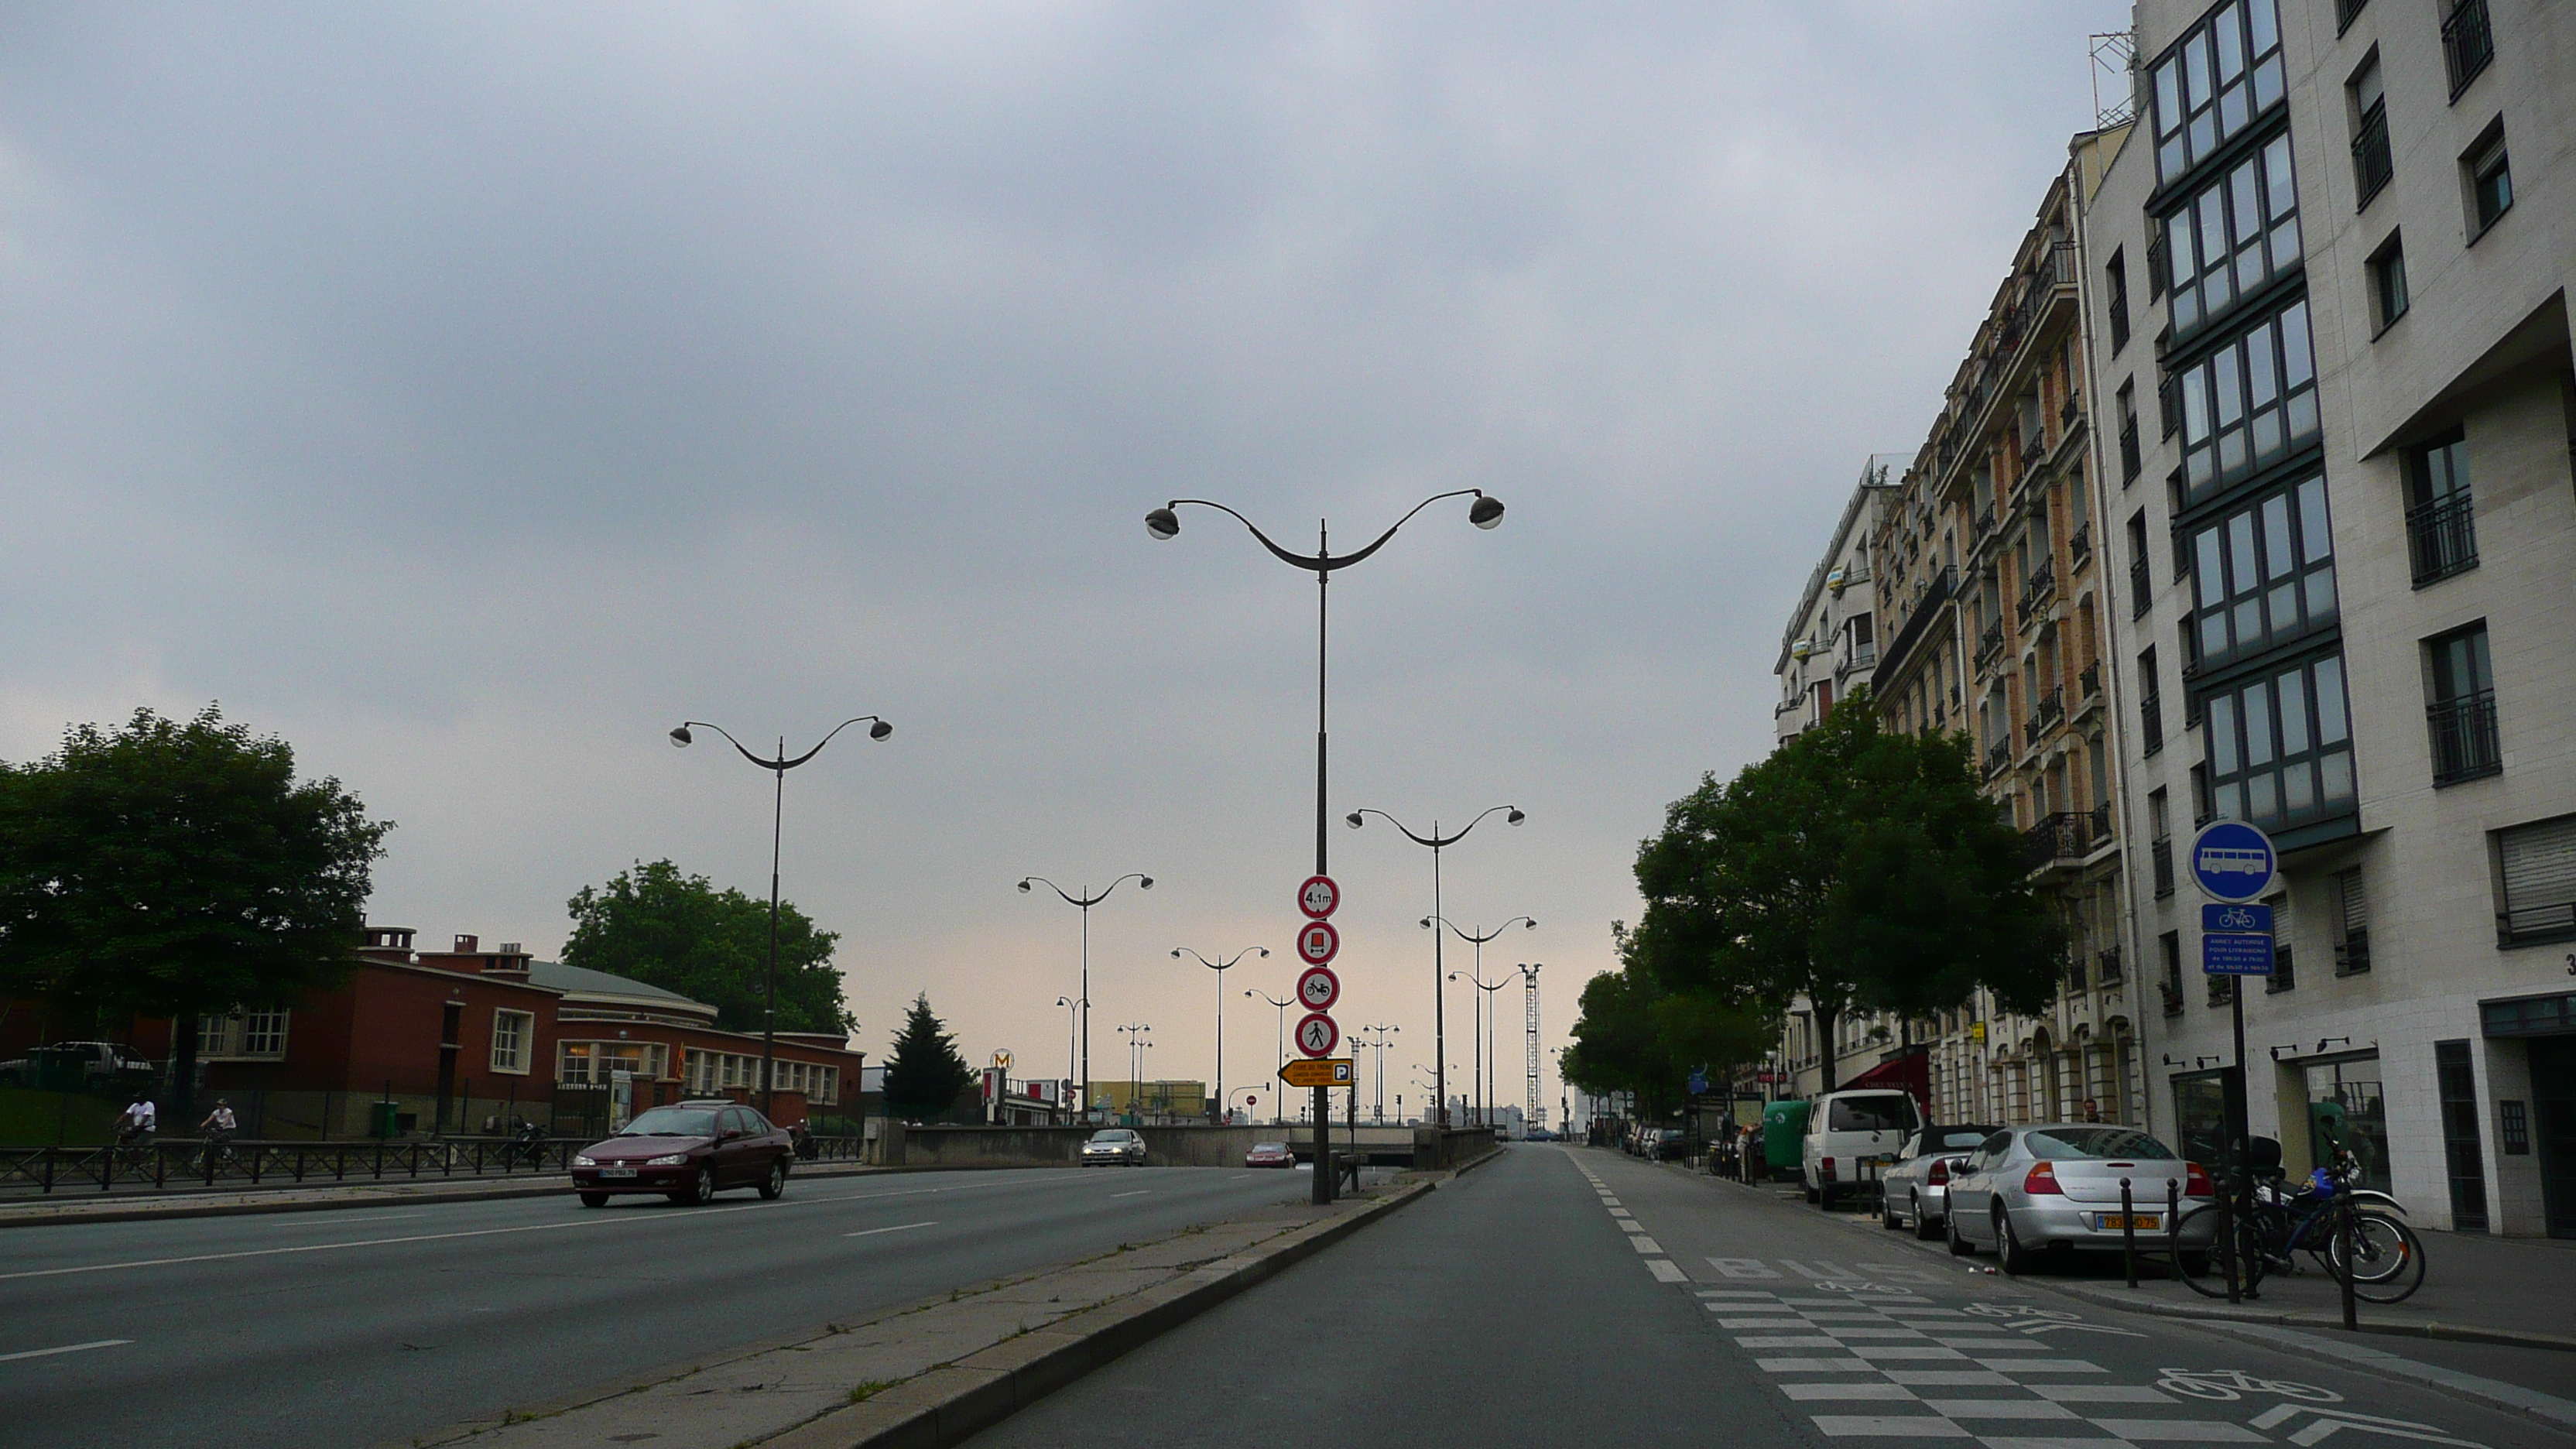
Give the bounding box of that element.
[0,1168,1306,1449]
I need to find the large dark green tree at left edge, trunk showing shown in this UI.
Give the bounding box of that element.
[0,704,394,1127]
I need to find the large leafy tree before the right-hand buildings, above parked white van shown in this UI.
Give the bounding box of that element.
[1631,691,2064,1091]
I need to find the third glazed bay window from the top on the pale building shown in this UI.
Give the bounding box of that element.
[2174,299,2316,503]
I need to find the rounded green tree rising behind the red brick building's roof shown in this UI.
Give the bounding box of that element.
[564,862,858,1031]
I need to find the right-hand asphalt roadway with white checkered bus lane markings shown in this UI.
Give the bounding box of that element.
[974,1145,2571,1449]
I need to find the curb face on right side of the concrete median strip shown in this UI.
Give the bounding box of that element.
[762,1181,1437,1449]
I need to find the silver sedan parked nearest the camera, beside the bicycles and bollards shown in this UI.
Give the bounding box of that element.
[1942,1122,2218,1273]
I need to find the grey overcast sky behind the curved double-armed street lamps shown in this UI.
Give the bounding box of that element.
[0,0,2128,1108]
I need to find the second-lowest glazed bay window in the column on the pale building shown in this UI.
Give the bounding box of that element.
[2192,477,2336,668]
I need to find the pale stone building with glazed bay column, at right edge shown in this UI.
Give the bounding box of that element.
[2079,0,2576,1235]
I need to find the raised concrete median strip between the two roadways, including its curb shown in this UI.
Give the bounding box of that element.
[379,1173,1447,1449]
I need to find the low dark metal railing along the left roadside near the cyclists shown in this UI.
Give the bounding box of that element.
[0,1137,865,1197]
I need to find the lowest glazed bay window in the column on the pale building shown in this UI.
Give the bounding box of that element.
[2202,655,2352,831]
